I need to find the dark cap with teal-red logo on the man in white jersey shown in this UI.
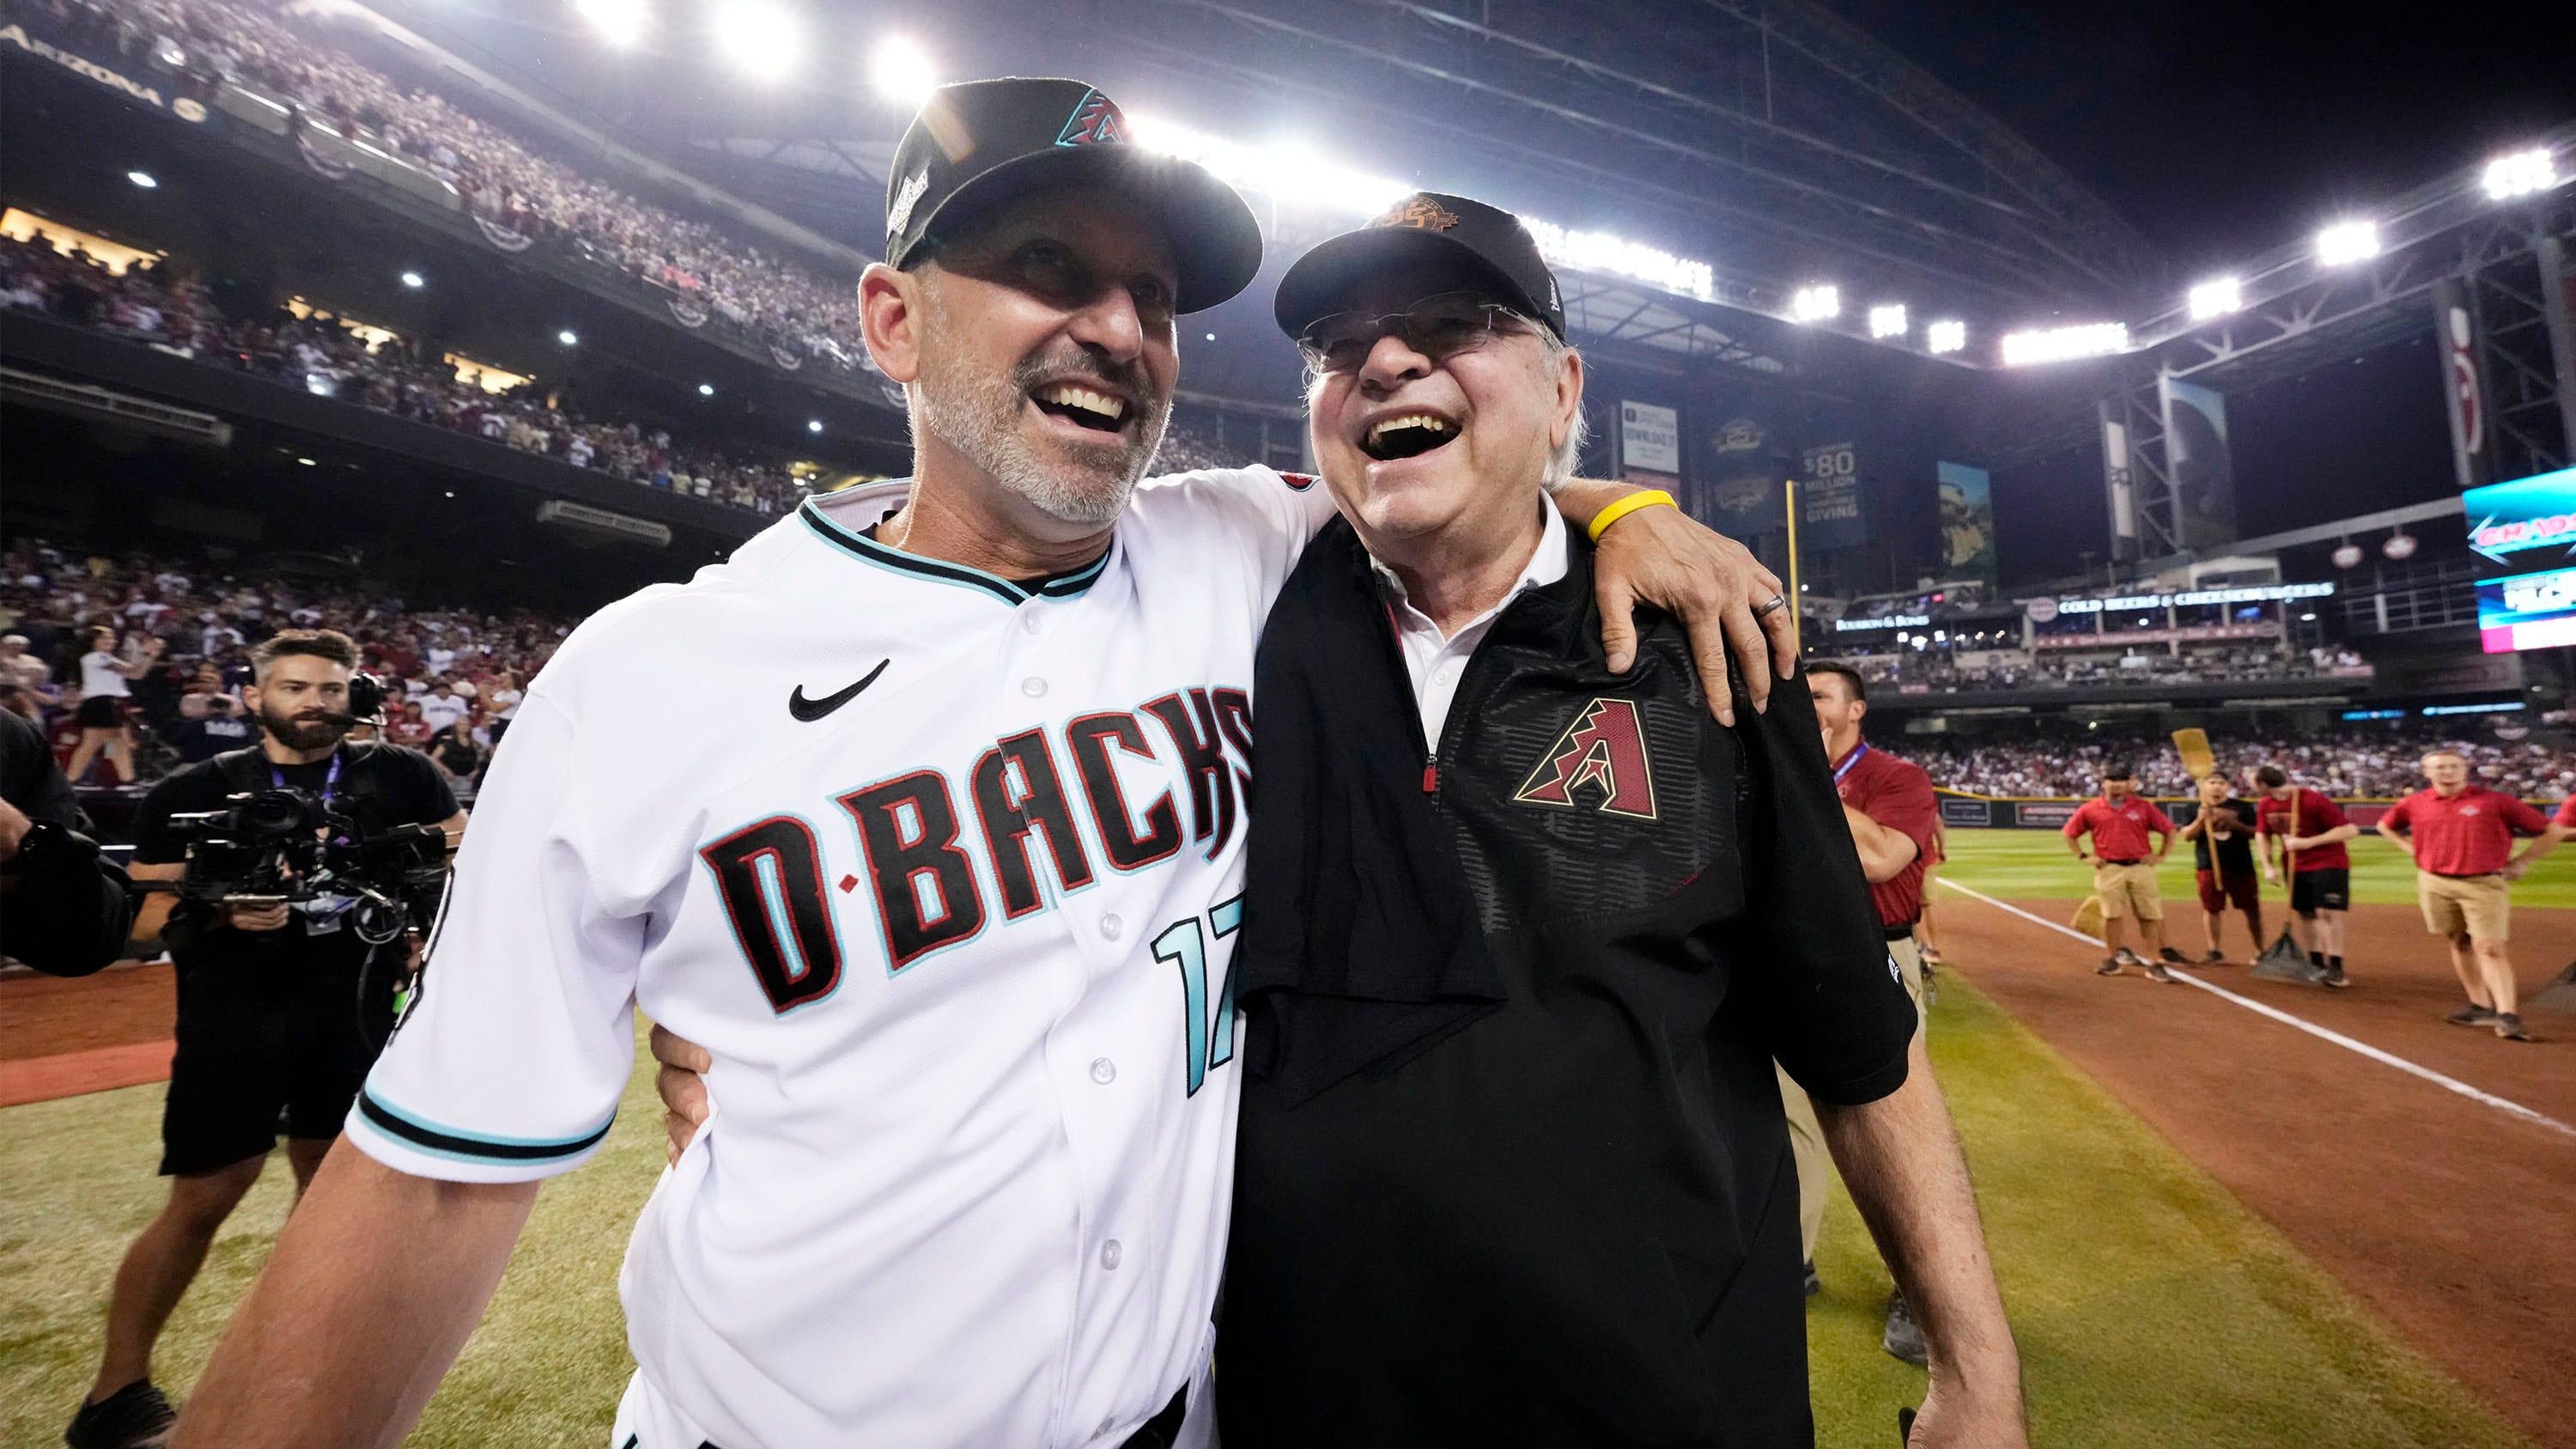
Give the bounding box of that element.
[886,77,1262,312]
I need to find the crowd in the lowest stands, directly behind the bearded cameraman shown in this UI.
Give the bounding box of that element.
[0,539,574,787]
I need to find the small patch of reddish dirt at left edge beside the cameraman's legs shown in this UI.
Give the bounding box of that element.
[0,965,178,1106]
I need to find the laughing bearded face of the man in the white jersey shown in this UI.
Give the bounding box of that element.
[860,188,1180,528]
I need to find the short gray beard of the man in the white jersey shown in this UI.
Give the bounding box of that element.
[914,343,1170,528]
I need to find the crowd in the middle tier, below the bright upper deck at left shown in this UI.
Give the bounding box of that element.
[0,237,804,513]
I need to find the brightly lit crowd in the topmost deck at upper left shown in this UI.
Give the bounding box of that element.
[0,0,866,368]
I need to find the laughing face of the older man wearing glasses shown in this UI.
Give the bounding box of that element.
[1306,265,1584,546]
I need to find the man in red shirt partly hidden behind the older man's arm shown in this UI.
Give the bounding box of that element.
[1775,662,1940,1367]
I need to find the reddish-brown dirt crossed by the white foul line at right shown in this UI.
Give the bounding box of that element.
[1940,892,2576,1449]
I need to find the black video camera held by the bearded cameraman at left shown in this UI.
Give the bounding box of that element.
[170,789,448,947]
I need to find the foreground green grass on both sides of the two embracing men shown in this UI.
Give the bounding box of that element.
[0,989,2527,1449]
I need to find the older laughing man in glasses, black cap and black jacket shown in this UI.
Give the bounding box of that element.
[1216,193,2025,1449]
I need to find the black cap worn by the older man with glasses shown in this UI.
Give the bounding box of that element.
[1275,191,1566,338]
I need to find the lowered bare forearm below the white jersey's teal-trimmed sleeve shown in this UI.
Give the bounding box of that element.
[170,1140,536,1449]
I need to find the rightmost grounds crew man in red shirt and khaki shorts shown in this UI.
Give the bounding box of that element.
[2380,751,2558,1042]
